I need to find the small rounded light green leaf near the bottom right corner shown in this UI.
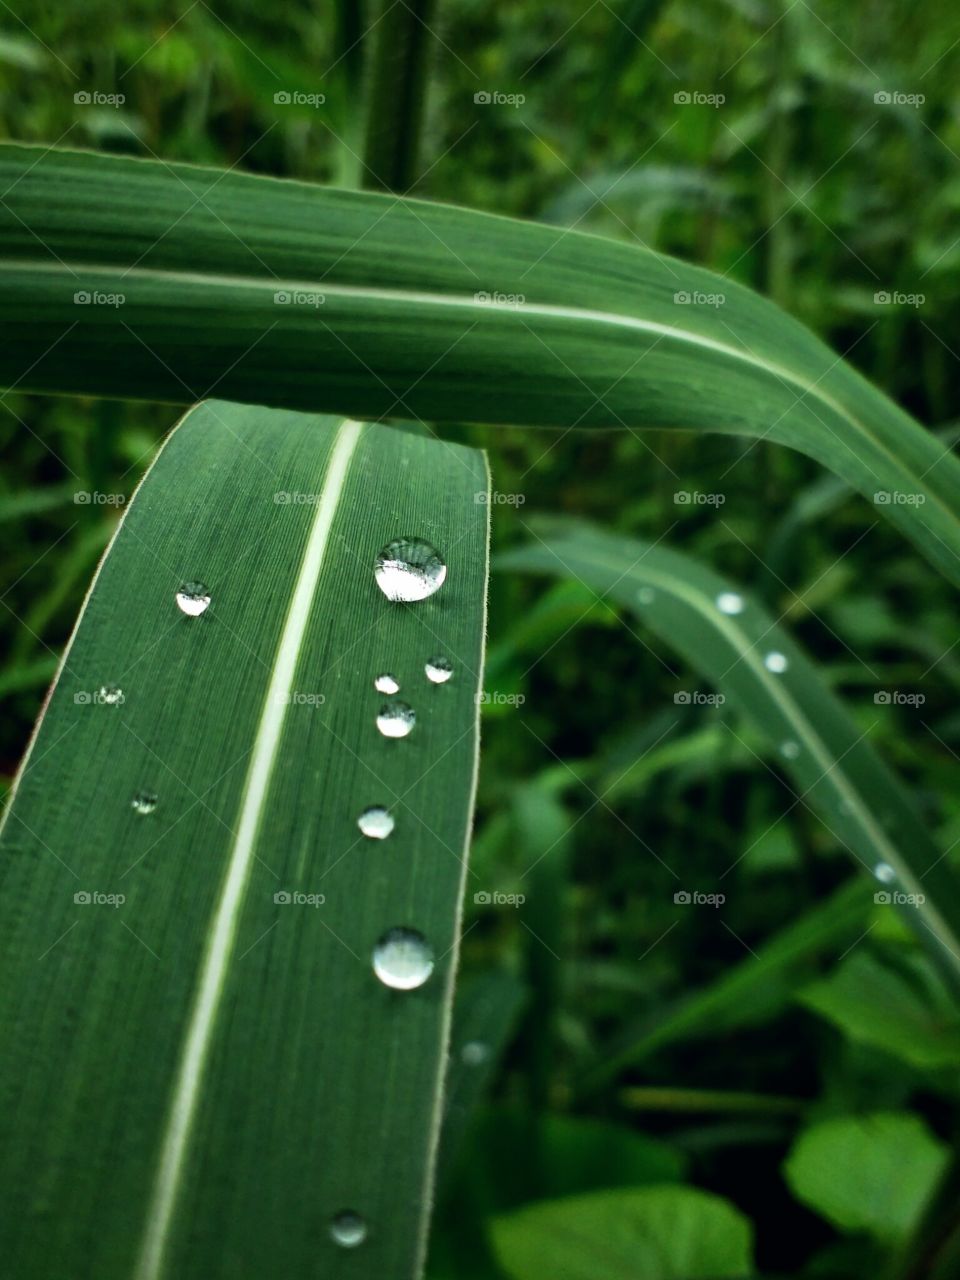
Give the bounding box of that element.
[783,1111,948,1243]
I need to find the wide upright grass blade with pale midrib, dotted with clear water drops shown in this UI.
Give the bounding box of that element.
[0,402,486,1280]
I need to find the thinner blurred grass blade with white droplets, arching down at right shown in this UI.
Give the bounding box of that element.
[498,520,960,978]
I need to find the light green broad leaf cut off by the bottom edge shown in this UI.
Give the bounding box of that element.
[492,1187,751,1280]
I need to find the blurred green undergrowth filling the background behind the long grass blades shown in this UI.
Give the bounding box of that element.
[0,0,960,1280]
